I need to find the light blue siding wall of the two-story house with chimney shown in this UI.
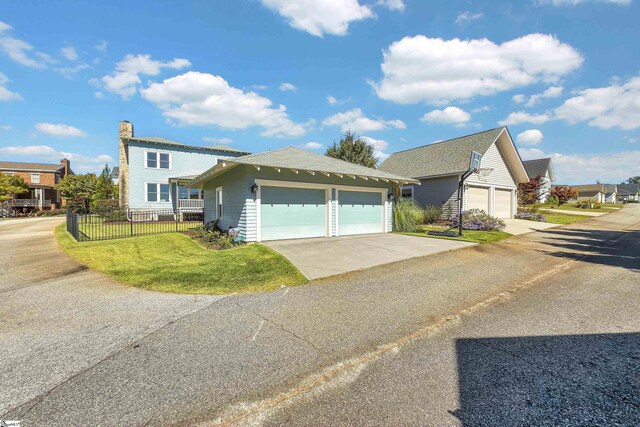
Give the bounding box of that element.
[128,141,242,209]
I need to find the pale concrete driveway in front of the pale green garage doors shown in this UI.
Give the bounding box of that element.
[265,233,474,279]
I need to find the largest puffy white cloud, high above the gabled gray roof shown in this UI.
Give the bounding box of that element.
[370,34,583,104]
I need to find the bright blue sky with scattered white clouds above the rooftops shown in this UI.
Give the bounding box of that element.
[0,0,640,184]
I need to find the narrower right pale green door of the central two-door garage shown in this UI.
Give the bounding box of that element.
[338,191,384,236]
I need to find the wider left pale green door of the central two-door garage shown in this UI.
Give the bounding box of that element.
[260,187,327,240]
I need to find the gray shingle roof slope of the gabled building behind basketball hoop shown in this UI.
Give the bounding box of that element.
[380,127,505,178]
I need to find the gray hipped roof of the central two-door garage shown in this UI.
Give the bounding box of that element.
[190,147,418,186]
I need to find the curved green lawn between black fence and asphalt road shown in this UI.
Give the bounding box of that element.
[56,224,307,294]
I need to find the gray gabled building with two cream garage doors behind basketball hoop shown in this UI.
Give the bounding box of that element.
[380,127,529,218]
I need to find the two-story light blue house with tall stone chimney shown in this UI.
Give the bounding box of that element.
[114,121,249,210]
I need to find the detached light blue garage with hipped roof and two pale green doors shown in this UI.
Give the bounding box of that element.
[189,147,419,242]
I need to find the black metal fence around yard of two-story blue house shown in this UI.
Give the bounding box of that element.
[67,209,204,242]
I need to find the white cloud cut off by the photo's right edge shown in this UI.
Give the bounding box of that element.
[554,76,640,130]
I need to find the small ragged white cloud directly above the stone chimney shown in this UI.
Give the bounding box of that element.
[102,54,191,99]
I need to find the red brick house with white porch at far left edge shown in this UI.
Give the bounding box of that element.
[0,159,73,211]
